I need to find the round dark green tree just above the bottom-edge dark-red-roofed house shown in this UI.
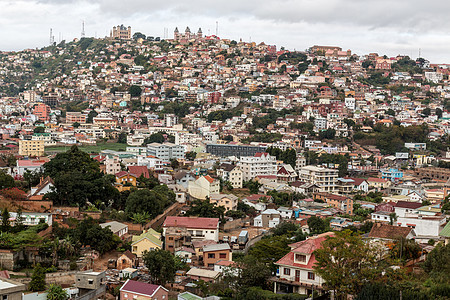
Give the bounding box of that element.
[142,249,177,285]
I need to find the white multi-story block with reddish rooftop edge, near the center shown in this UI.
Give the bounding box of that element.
[239,152,277,181]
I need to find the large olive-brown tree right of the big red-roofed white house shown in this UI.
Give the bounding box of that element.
[314,230,383,299]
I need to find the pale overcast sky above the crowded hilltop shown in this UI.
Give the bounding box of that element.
[0,0,450,63]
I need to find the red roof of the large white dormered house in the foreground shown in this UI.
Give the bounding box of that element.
[275,232,334,270]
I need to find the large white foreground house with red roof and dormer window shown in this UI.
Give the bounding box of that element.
[273,232,334,294]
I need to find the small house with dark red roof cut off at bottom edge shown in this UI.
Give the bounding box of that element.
[119,279,169,300]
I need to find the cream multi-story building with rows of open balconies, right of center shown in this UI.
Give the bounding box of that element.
[298,166,339,192]
